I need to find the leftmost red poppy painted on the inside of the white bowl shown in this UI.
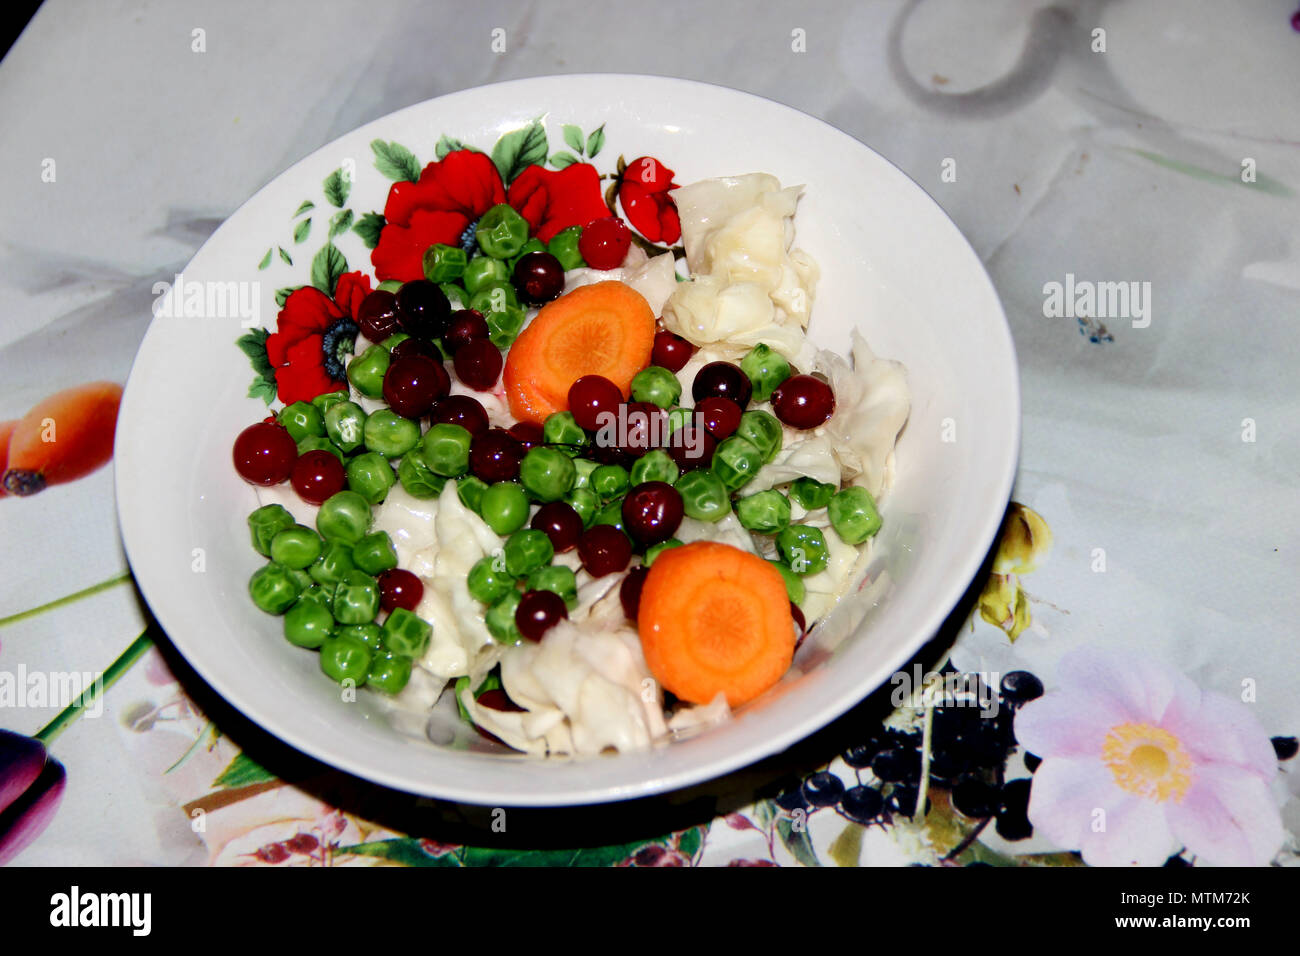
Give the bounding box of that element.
[267,272,371,405]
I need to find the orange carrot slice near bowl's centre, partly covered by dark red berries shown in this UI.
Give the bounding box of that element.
[503,281,654,424]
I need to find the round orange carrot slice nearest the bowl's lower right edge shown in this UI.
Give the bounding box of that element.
[637,541,794,708]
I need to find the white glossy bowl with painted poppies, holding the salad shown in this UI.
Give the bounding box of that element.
[116,75,1021,805]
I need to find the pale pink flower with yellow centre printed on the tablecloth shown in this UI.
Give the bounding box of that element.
[1015,649,1283,866]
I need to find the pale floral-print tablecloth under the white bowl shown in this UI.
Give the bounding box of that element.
[0,0,1300,866]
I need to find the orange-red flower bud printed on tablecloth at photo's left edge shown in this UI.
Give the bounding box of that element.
[4,381,122,496]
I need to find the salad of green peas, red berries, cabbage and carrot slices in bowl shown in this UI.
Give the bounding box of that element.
[234,160,910,754]
